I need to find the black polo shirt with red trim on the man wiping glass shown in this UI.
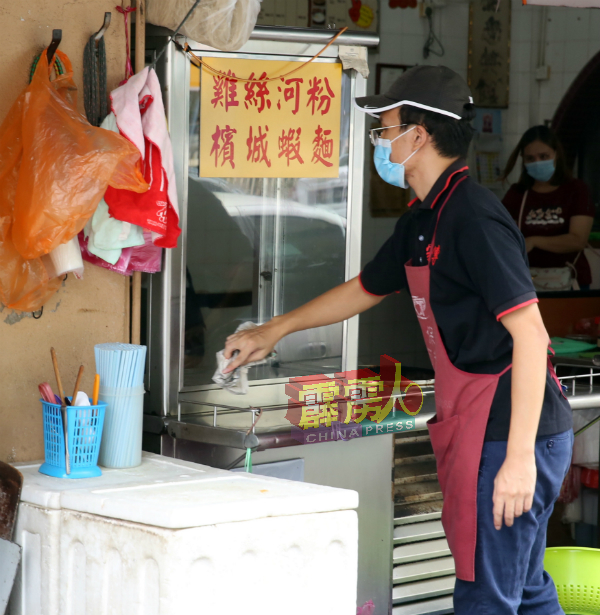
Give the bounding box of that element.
[359,160,572,440]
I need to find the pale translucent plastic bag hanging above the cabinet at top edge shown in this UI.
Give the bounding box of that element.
[146,0,260,51]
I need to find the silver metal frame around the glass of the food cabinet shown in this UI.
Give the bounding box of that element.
[146,27,378,420]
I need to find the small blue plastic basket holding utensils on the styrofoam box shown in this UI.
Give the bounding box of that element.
[40,400,106,478]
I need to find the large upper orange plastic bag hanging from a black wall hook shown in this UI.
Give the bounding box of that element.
[5,50,148,259]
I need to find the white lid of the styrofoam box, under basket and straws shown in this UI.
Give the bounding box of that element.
[16,453,358,528]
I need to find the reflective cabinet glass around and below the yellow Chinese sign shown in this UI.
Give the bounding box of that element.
[184,69,350,387]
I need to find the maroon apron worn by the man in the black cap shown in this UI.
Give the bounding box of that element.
[405,177,510,581]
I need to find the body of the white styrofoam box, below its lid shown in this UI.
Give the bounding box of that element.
[9,504,358,615]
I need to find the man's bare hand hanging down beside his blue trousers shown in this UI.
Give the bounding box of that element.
[492,454,537,530]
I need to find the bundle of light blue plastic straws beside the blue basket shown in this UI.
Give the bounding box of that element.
[94,343,146,468]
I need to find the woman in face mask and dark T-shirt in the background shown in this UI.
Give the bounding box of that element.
[502,126,594,290]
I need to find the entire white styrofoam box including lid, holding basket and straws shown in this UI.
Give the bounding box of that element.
[9,453,358,615]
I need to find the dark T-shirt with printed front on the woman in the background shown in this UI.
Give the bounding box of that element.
[502,179,595,285]
